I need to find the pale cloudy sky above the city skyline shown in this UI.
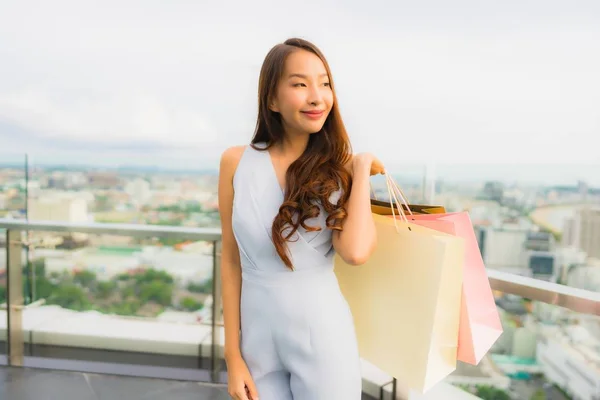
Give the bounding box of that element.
[0,0,600,185]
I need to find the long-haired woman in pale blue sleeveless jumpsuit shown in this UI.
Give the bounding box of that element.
[219,39,383,400]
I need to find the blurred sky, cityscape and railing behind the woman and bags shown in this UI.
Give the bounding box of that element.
[0,0,600,400]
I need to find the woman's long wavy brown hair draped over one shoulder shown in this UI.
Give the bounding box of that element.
[251,38,352,270]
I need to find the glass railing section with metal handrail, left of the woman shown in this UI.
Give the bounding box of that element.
[0,220,223,381]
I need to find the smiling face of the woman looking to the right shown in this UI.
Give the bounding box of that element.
[270,50,334,135]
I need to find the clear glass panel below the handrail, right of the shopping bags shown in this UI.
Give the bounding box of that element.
[445,293,600,400]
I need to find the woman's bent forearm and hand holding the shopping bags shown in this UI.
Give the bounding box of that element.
[332,153,384,265]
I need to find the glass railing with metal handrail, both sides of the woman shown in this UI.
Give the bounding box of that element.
[0,219,600,399]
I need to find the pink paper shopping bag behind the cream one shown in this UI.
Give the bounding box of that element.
[382,177,503,365]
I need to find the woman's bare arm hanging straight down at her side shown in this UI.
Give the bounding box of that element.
[218,146,258,400]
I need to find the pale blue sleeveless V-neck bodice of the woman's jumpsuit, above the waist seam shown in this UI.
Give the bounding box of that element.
[232,144,340,271]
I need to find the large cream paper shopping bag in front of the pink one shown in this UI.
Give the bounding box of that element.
[335,214,465,393]
